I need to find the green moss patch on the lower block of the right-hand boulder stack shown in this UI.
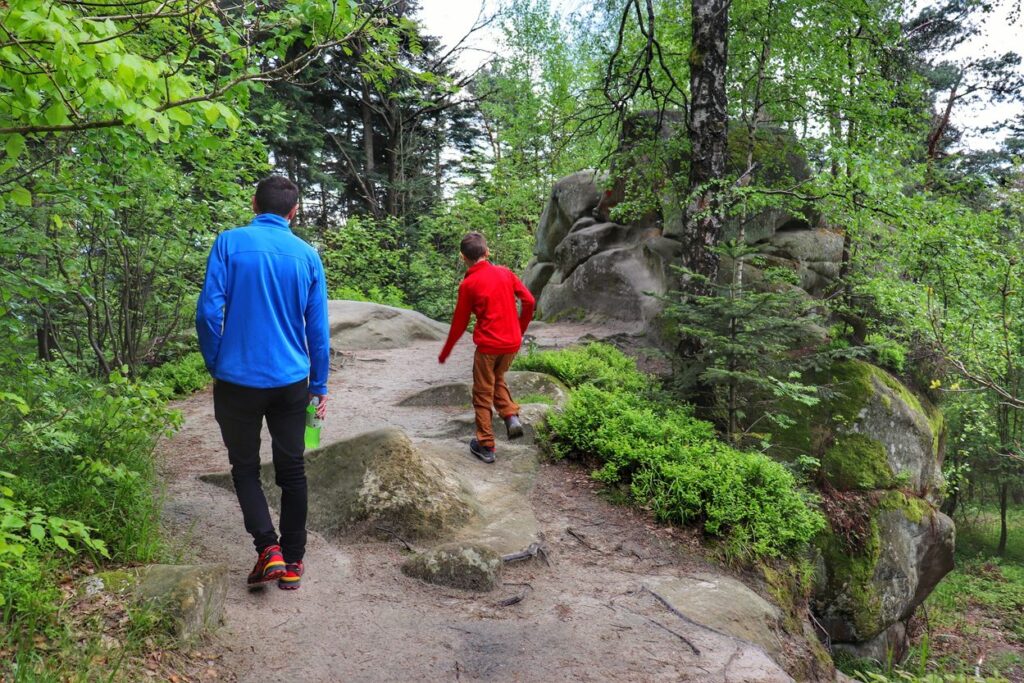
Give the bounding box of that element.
[815,519,882,637]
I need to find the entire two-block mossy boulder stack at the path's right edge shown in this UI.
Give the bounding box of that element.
[771,360,954,651]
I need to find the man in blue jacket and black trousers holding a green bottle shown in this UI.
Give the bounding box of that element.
[196,176,330,590]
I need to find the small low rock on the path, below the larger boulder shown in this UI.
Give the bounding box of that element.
[401,543,502,591]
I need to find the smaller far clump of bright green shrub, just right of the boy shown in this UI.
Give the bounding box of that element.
[512,342,651,391]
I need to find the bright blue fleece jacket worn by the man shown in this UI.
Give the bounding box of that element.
[196,213,331,394]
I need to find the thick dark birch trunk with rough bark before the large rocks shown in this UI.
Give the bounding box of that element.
[683,0,729,281]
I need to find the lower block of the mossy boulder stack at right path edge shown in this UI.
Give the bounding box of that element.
[813,490,954,645]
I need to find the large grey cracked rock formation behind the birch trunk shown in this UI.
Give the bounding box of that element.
[523,168,843,325]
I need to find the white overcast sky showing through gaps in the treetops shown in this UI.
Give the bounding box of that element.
[421,0,1024,148]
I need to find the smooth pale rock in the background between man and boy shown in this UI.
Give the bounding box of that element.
[328,300,447,350]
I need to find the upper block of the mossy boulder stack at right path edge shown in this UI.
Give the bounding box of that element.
[771,360,945,503]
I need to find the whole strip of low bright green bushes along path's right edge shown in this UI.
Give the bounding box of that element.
[516,343,824,560]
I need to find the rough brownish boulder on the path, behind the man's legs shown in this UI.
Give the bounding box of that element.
[203,429,473,539]
